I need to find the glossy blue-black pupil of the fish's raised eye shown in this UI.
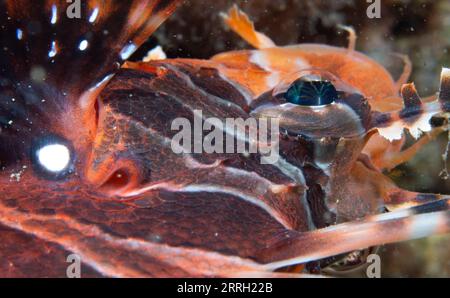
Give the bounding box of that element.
[285,79,338,106]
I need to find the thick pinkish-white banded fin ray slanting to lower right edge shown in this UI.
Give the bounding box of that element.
[261,200,450,270]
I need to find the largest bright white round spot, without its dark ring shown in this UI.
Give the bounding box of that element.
[37,144,70,172]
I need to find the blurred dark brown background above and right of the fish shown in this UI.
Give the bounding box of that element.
[148,0,450,277]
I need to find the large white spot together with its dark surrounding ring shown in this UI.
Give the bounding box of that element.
[31,136,74,179]
